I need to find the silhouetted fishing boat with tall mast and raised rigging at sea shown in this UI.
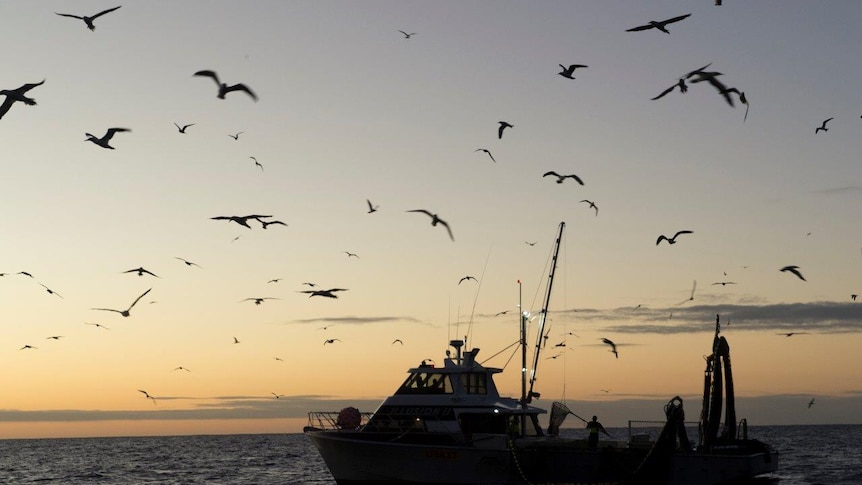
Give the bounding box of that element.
[304,223,778,485]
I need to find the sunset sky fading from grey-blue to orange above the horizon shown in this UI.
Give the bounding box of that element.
[0,0,862,438]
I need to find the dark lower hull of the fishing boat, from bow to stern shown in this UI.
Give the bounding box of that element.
[306,429,778,485]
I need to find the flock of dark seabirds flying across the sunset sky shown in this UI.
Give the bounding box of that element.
[5,2,857,416]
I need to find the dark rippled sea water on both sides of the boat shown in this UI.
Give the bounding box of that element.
[0,425,862,485]
